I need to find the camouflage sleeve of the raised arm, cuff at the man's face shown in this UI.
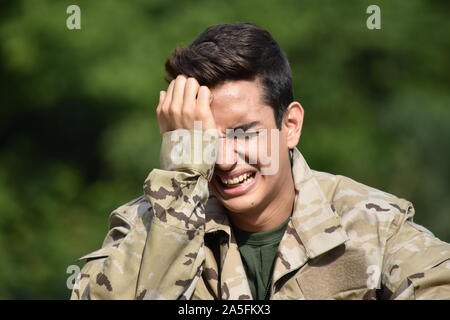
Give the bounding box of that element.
[72,130,217,299]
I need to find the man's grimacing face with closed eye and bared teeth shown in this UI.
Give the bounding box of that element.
[209,80,292,214]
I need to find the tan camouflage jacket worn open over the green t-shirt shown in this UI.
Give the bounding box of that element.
[71,131,450,299]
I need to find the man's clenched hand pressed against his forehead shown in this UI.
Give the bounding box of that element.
[156,75,216,134]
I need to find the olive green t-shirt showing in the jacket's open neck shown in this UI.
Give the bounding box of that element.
[233,218,290,300]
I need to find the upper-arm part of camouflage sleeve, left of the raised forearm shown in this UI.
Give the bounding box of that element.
[71,197,151,300]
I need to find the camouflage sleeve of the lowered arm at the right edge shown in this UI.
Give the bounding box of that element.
[382,205,450,300]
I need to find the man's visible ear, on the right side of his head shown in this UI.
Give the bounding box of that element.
[281,101,304,149]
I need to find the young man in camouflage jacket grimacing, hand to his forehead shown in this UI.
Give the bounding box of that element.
[72,23,450,299]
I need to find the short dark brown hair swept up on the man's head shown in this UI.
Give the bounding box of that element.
[165,22,293,128]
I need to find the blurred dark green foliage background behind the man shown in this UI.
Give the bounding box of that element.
[0,0,450,299]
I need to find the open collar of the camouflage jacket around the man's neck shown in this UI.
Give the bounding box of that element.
[205,148,348,258]
